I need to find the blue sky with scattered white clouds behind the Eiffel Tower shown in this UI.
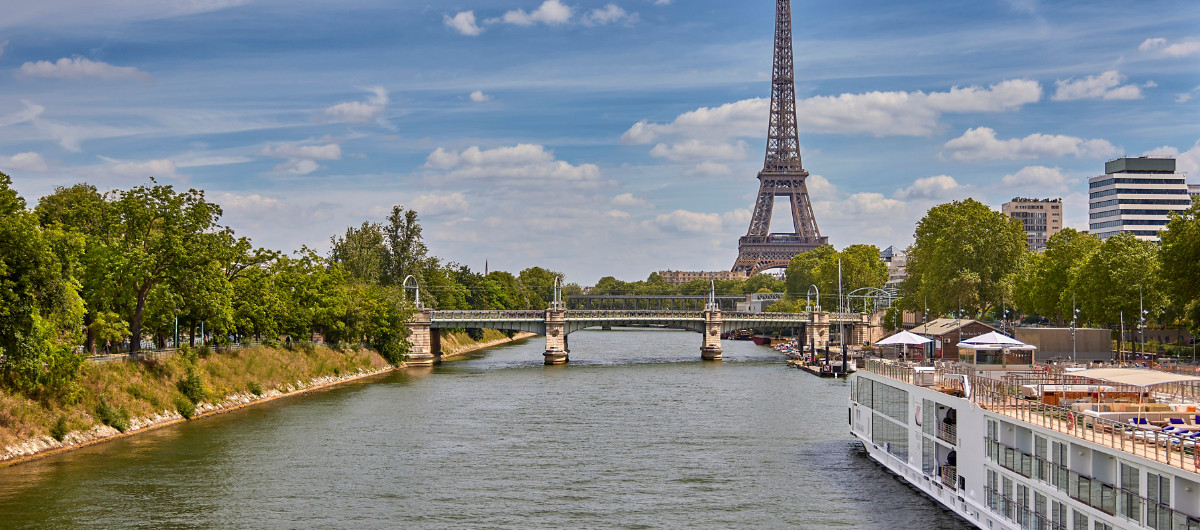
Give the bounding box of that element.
[0,0,1200,284]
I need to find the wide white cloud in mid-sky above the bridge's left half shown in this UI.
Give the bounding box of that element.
[425,144,601,185]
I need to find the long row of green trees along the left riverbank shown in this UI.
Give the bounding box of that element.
[0,173,563,395]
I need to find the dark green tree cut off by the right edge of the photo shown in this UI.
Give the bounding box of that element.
[1159,200,1200,330]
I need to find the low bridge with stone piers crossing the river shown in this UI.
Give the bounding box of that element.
[408,302,868,365]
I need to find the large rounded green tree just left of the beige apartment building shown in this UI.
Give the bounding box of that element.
[901,199,1030,315]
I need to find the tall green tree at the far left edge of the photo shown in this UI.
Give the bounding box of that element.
[0,173,84,395]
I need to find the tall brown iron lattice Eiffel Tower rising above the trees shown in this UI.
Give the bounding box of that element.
[733,0,829,275]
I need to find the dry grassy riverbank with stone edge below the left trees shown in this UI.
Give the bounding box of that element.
[0,330,533,468]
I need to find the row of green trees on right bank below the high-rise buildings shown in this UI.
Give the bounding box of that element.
[900,199,1200,338]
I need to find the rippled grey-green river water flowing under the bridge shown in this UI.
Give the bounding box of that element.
[0,330,962,529]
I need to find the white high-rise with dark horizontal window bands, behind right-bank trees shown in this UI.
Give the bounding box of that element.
[1087,156,1192,242]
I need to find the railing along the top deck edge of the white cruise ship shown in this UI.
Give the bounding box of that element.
[864,359,1200,472]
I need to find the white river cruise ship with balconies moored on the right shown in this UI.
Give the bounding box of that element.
[850,360,1200,530]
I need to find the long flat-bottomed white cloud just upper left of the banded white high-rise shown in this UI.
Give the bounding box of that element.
[941,127,1121,162]
